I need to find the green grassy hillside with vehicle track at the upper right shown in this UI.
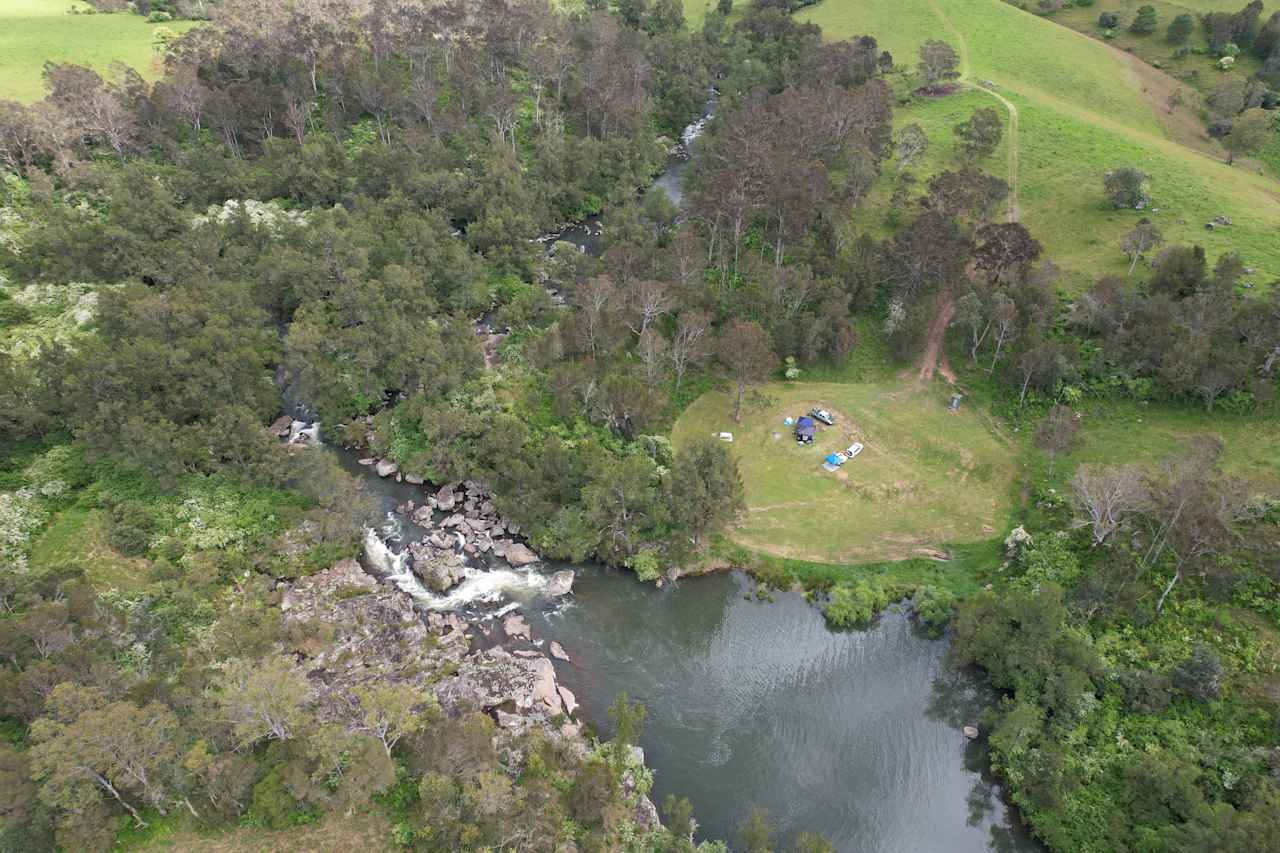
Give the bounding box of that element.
[800,0,1280,282]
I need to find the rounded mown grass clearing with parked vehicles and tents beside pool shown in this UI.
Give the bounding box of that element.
[672,382,1014,565]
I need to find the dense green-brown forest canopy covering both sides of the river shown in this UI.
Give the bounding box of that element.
[0,0,1280,850]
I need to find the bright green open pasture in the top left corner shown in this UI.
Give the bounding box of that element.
[0,0,196,102]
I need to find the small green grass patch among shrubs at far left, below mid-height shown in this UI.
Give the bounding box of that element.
[31,506,147,592]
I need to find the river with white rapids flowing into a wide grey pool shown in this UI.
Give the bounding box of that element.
[293,101,1041,853]
